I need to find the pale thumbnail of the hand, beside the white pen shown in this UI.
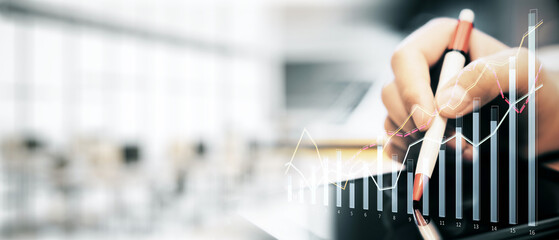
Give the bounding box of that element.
[435,85,472,113]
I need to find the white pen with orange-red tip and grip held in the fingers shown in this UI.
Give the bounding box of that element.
[413,9,474,201]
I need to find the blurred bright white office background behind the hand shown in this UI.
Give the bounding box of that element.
[0,0,558,239]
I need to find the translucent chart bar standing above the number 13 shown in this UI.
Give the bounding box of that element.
[472,98,480,221]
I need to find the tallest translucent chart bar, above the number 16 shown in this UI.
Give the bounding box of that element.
[526,9,538,226]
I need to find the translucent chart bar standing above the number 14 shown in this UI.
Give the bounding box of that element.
[489,106,499,223]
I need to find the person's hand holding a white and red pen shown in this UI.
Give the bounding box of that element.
[382,18,559,159]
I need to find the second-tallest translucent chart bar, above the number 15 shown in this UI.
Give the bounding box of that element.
[509,56,517,224]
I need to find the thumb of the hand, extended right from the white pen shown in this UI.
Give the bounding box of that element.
[435,49,528,118]
